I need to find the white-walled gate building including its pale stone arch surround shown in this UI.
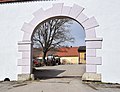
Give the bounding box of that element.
[0,0,120,83]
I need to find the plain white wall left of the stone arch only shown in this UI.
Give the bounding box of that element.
[0,2,54,80]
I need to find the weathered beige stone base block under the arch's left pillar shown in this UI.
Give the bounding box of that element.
[18,74,34,81]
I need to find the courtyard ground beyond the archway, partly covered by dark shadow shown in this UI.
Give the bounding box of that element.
[33,64,86,79]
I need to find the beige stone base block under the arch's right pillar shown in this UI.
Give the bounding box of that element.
[82,73,101,81]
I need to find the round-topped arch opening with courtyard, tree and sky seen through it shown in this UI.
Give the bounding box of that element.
[31,16,86,79]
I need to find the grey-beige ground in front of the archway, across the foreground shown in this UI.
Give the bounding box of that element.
[0,78,120,92]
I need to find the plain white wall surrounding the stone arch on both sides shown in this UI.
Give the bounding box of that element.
[0,0,120,83]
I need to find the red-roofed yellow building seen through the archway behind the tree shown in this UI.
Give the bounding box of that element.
[33,46,86,64]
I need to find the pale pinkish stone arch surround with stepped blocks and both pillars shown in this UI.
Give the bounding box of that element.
[18,3,102,81]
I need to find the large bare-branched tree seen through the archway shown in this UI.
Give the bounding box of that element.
[32,18,74,61]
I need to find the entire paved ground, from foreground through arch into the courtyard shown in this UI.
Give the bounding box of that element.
[0,65,120,92]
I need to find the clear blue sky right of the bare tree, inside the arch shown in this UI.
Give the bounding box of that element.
[68,20,85,47]
